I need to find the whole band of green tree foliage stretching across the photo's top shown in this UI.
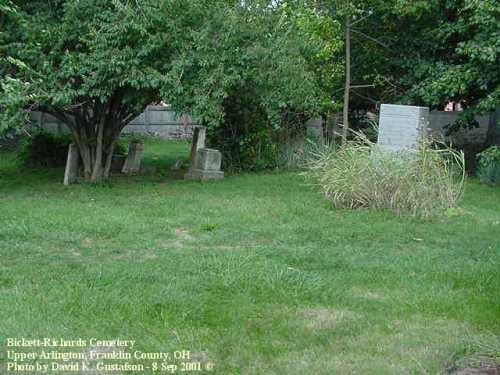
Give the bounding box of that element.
[0,0,500,174]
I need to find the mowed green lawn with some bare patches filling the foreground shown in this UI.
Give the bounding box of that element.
[0,140,500,374]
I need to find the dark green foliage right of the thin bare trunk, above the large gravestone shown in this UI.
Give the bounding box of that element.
[309,0,500,131]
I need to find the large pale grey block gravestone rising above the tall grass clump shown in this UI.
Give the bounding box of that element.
[377,104,429,151]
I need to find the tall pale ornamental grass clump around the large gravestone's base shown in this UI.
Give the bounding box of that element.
[306,134,465,217]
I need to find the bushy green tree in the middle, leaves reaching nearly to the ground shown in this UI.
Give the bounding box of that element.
[148,1,329,169]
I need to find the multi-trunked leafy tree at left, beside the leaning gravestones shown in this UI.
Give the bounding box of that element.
[1,0,172,182]
